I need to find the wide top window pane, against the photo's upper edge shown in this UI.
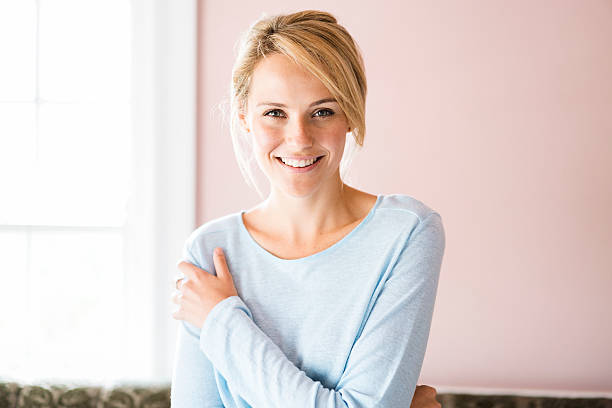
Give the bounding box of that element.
[40,0,131,102]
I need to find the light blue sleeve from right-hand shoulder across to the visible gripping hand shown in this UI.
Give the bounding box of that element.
[200,212,445,408]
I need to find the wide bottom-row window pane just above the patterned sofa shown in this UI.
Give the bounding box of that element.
[27,230,124,380]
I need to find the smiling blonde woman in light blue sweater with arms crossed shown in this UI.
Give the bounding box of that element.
[172,11,445,408]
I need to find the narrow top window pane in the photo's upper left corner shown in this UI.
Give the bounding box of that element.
[0,0,36,101]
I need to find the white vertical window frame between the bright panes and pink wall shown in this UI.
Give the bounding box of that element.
[123,0,197,383]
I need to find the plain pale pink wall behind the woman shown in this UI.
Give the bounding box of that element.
[197,0,612,392]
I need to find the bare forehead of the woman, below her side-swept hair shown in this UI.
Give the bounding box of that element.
[249,53,332,104]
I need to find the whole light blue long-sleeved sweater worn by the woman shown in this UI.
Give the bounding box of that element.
[171,194,445,408]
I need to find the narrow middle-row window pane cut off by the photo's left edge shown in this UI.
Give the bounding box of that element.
[0,103,36,224]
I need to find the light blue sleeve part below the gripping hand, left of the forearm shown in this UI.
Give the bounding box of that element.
[170,321,223,408]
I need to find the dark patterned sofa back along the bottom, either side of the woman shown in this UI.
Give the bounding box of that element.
[0,382,612,408]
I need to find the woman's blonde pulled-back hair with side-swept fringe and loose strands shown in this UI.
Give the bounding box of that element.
[230,10,367,196]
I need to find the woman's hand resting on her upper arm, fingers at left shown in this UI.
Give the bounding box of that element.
[172,248,238,328]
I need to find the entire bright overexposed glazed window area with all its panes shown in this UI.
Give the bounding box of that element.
[0,0,131,381]
